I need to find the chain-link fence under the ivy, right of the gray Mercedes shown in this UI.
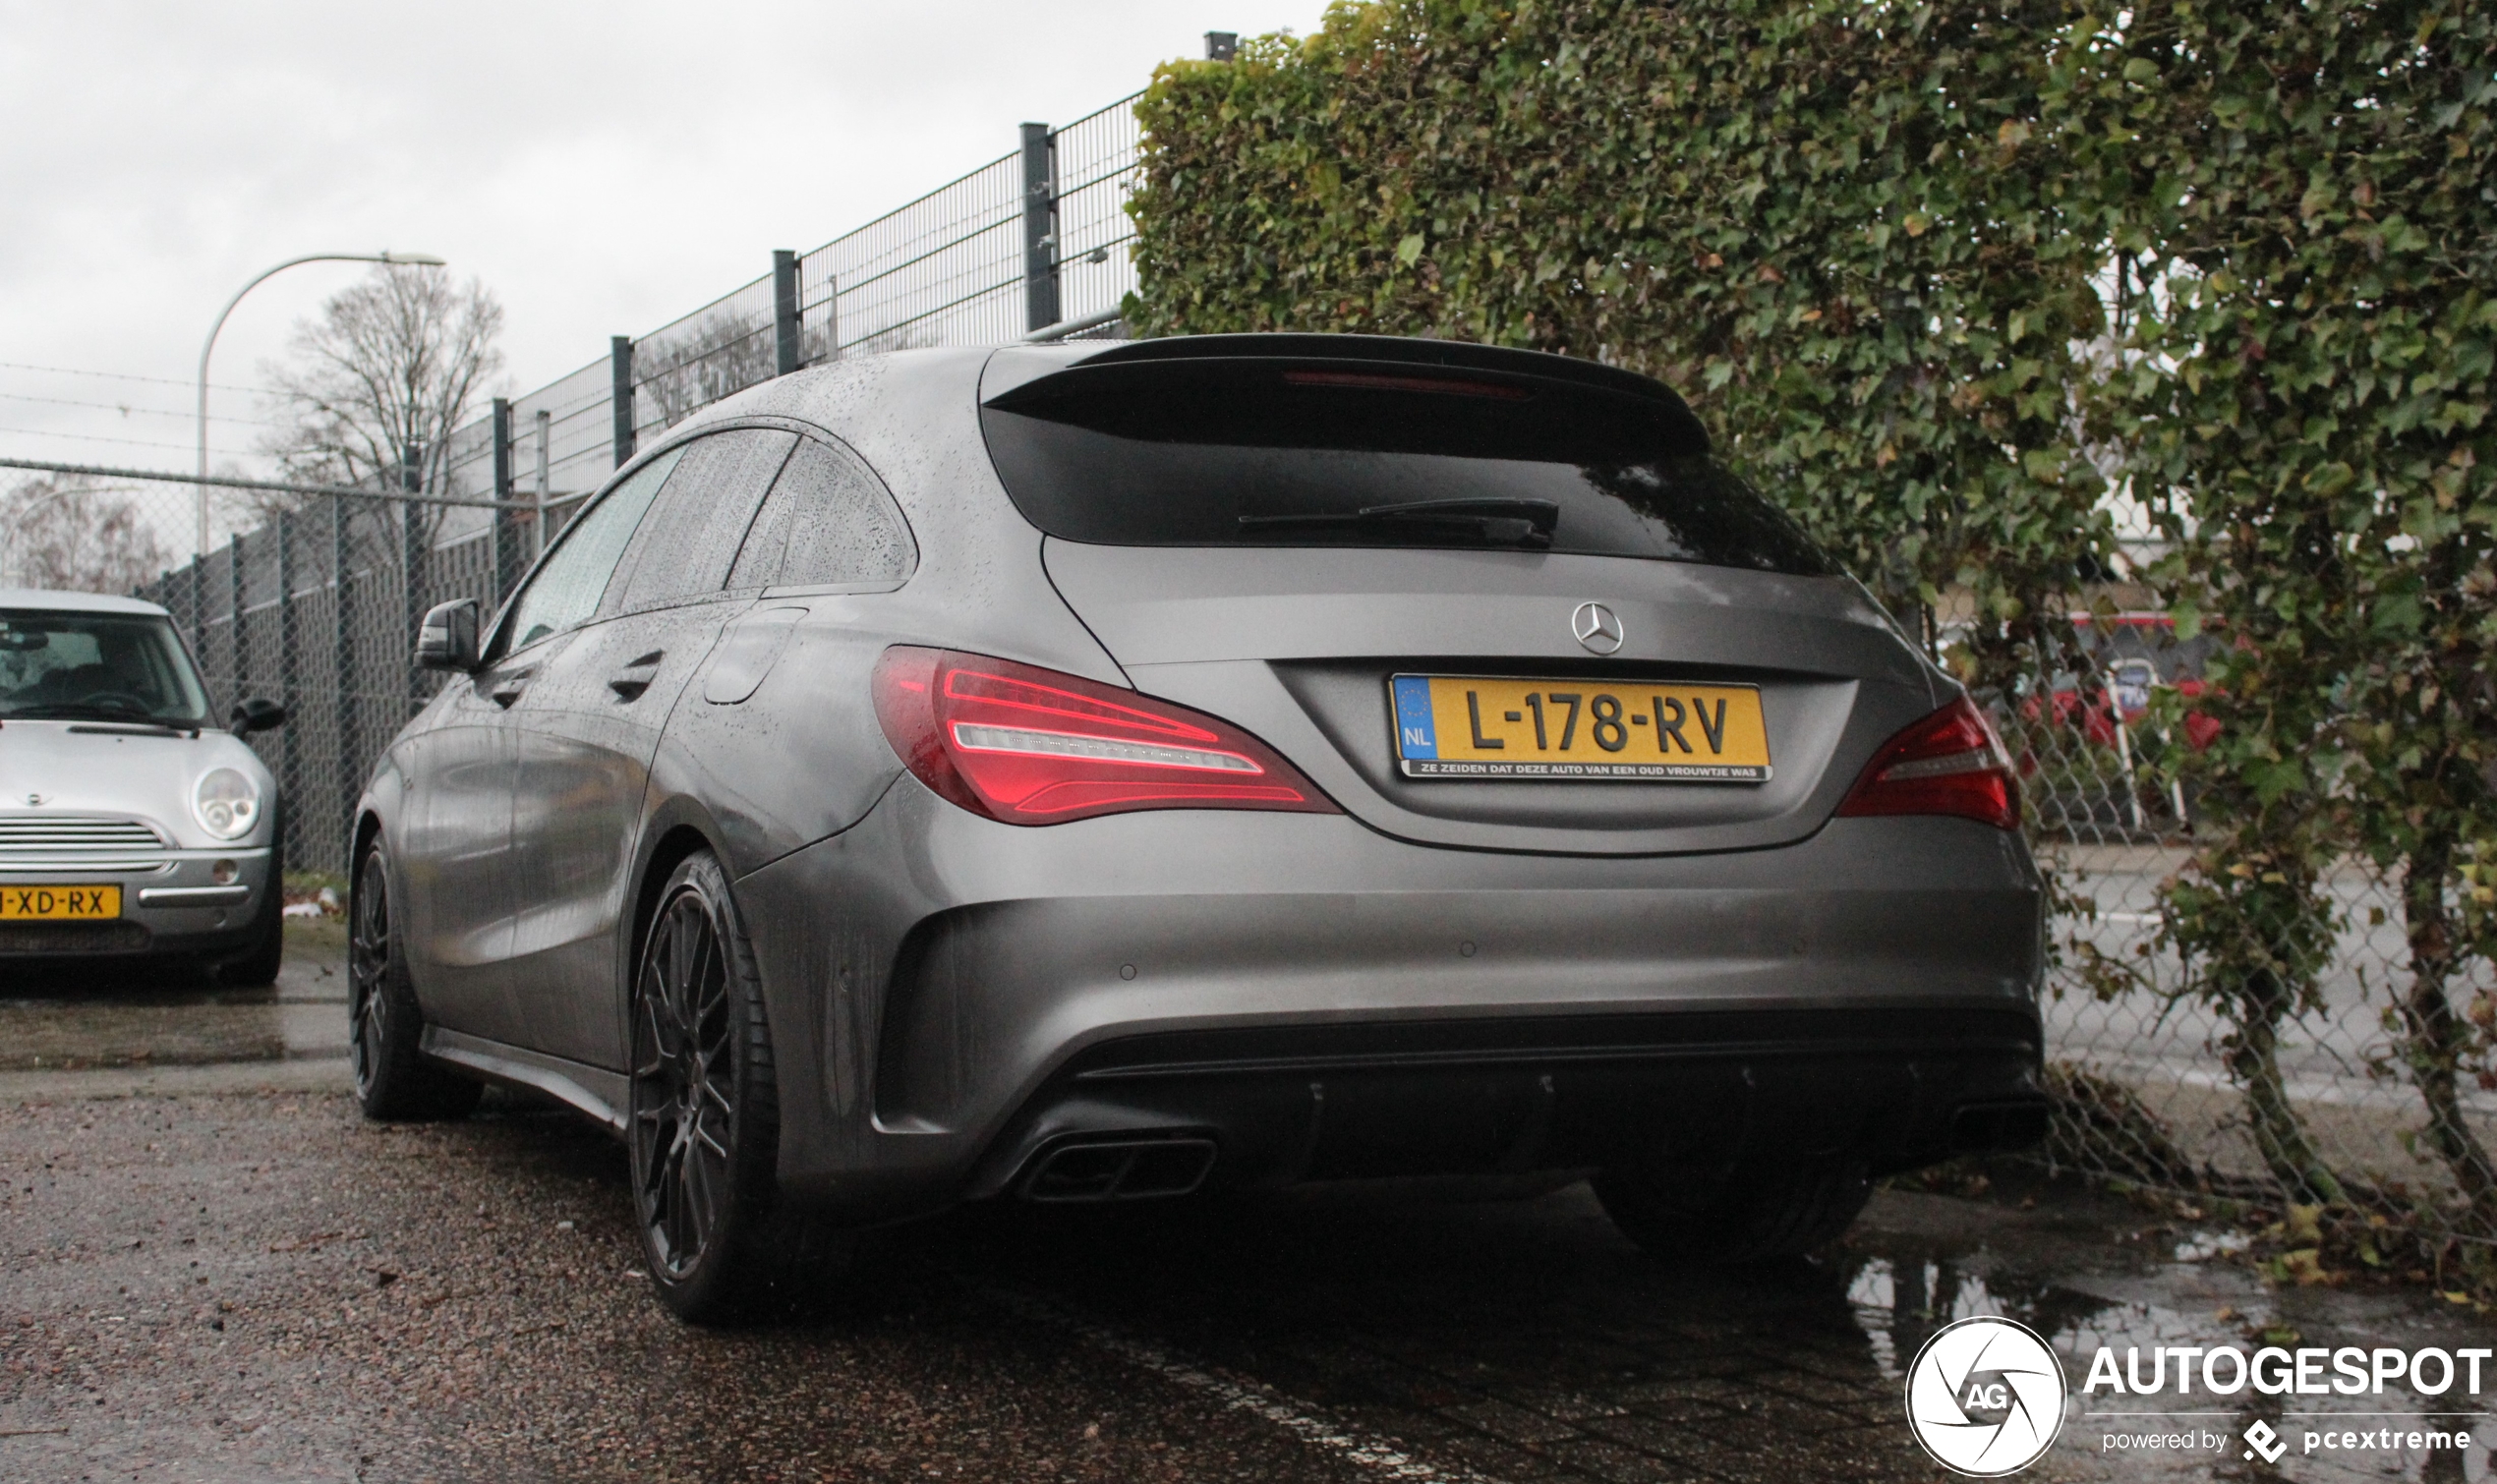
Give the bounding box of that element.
[1995,614,2497,1277]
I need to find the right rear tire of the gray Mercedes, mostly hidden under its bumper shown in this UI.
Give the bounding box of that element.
[1596,1160,1873,1267]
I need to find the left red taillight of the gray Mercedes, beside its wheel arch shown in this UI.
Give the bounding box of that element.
[874,645,1341,825]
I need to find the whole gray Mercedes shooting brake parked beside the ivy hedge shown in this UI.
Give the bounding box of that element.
[352,335,2043,1319]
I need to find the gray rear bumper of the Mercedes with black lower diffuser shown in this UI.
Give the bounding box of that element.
[739,779,2040,1220]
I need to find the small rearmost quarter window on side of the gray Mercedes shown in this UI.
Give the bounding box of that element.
[729,439,919,587]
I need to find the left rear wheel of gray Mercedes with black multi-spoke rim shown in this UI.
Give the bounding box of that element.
[627,852,849,1324]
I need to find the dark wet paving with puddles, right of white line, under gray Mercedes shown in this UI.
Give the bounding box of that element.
[929,1184,2497,1484]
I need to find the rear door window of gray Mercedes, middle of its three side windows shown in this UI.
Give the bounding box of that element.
[600,428,796,612]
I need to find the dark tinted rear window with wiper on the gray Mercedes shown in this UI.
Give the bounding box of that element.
[981,360,1835,577]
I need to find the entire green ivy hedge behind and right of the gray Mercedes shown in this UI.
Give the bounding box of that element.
[1129,0,2497,1244]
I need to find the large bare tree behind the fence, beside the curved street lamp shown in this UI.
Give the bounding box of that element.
[262,264,502,512]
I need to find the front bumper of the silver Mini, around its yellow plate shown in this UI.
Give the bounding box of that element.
[0,847,279,959]
